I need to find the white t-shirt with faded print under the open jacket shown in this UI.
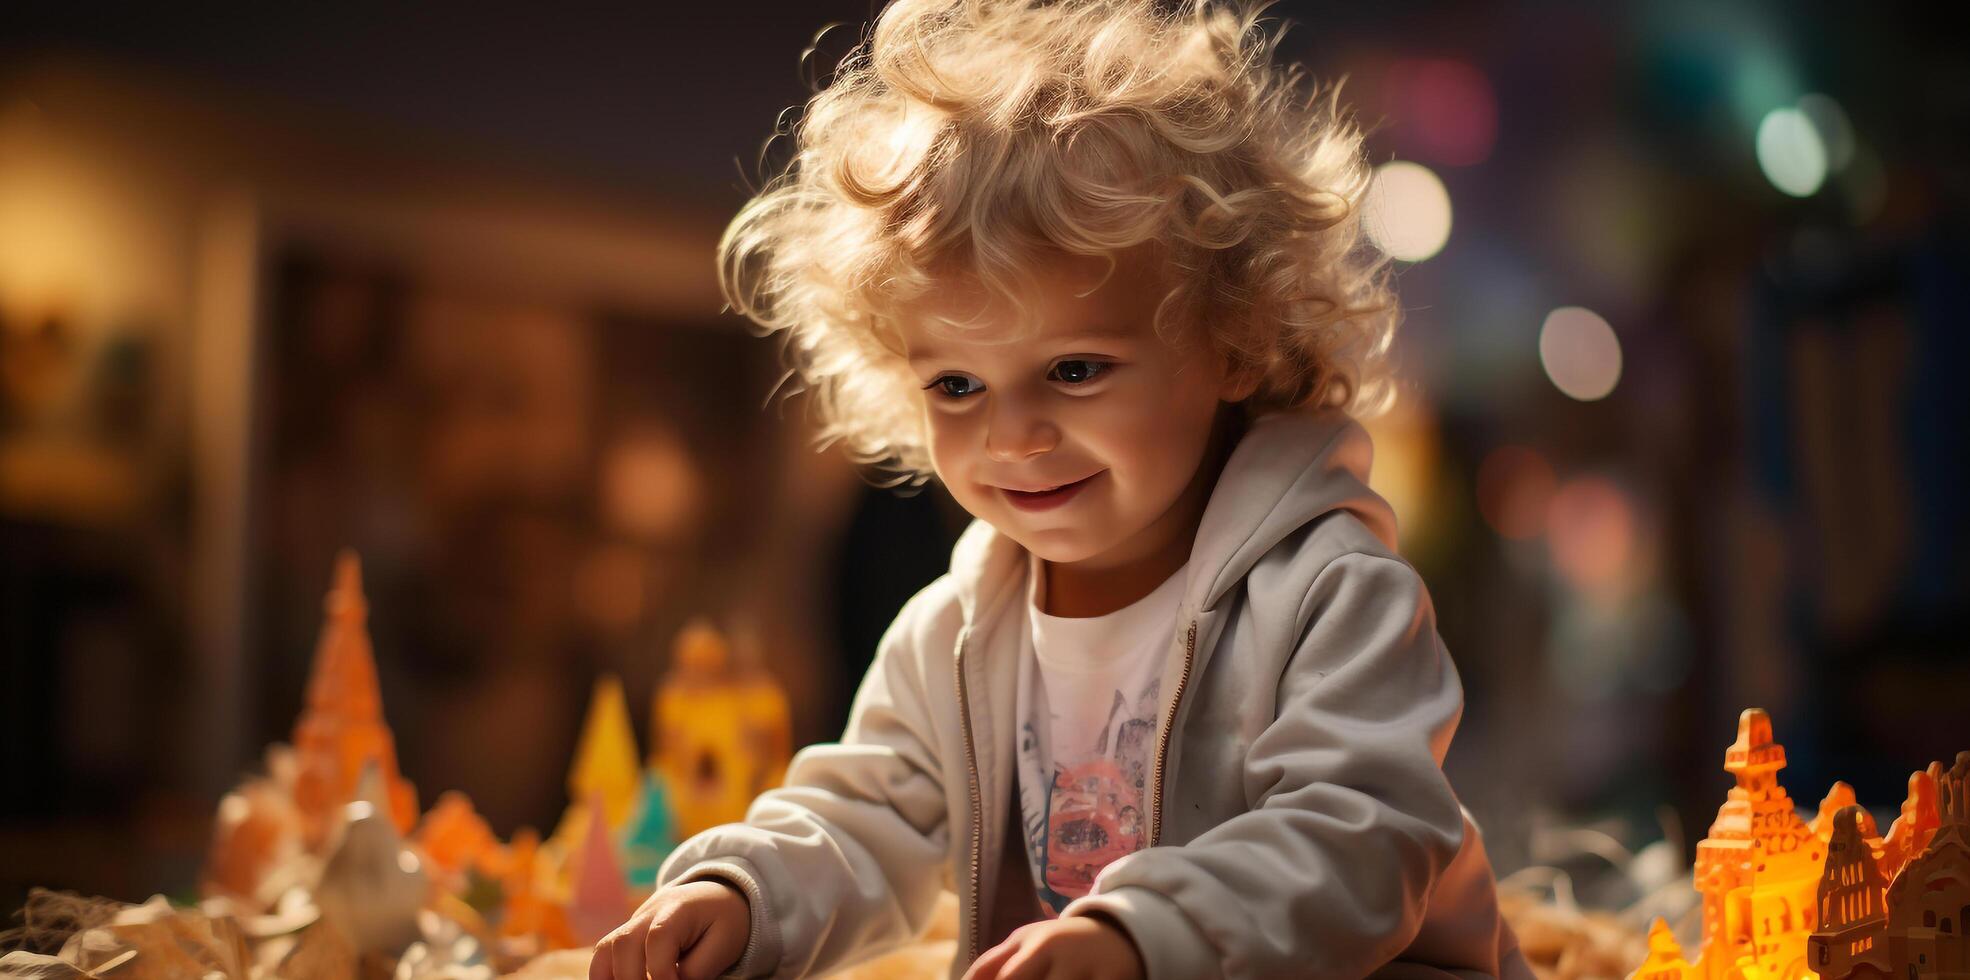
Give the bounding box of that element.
[1015,560,1184,915]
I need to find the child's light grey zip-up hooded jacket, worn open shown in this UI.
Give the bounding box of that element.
[658,412,1531,980]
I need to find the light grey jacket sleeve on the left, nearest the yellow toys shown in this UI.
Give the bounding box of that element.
[658,575,955,976]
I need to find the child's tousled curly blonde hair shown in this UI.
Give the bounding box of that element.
[719,0,1399,481]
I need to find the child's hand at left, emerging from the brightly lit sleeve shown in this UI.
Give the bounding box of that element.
[589,881,753,980]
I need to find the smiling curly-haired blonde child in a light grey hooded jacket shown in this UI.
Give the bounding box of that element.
[591,0,1531,980]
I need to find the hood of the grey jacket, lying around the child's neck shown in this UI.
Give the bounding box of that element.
[952,408,1395,623]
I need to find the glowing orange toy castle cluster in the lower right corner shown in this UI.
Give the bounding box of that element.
[1631,708,1970,980]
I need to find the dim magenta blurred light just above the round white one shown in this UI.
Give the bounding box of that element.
[1389,57,1497,168]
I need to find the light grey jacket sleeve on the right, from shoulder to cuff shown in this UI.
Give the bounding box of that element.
[1064,554,1464,980]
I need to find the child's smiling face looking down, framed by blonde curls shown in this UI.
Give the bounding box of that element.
[902,256,1239,568]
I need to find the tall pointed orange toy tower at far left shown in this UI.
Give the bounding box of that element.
[294,550,418,848]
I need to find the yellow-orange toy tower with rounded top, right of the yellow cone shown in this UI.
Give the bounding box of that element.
[650,621,792,838]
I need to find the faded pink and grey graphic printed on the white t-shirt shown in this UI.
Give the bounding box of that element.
[1018,678,1160,915]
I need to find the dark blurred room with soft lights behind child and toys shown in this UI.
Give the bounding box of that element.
[0,0,1970,911]
